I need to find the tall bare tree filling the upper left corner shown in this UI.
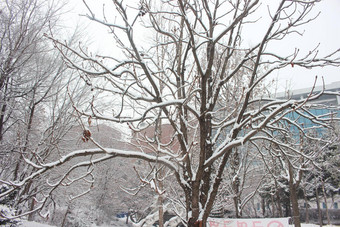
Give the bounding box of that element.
[0,0,60,140]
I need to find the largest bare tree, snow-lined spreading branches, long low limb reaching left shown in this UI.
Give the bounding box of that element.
[1,0,340,226]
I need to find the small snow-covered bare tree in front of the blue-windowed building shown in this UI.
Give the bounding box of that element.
[261,107,337,224]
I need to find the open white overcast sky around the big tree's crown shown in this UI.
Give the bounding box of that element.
[63,0,340,91]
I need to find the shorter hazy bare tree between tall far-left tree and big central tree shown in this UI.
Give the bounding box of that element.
[1,48,86,220]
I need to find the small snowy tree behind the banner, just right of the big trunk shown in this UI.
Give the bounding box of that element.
[212,143,266,218]
